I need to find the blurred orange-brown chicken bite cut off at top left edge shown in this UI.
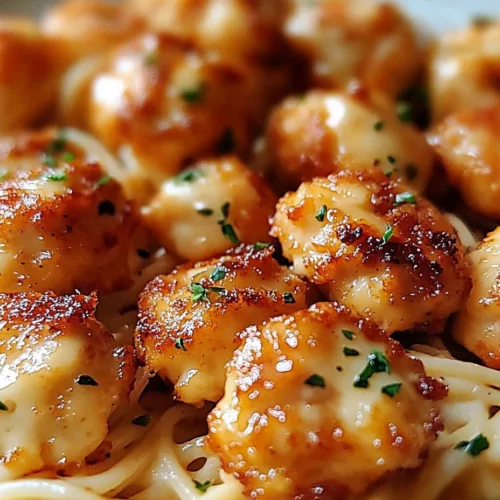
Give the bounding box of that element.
[0,21,62,132]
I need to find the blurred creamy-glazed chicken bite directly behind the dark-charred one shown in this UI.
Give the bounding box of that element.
[265,90,433,191]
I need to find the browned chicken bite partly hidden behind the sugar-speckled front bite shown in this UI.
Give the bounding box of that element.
[135,245,308,404]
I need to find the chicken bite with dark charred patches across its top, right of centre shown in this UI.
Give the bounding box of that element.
[272,170,468,333]
